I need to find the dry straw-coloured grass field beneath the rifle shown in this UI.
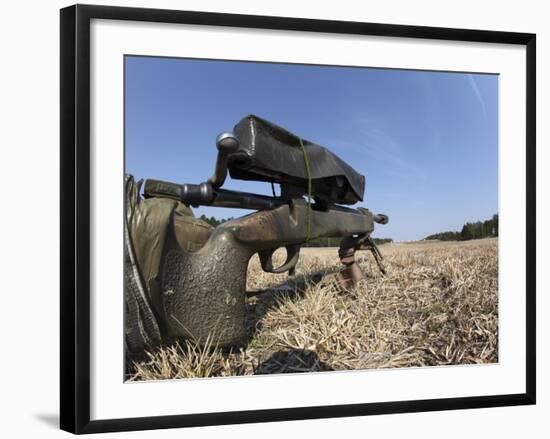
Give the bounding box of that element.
[128,239,498,380]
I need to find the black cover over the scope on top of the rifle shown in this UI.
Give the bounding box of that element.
[228,115,365,204]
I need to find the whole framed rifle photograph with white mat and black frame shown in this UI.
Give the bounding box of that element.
[61,5,536,433]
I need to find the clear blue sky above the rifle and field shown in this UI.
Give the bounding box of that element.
[125,56,498,240]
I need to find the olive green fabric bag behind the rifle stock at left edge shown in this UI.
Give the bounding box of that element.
[124,175,212,353]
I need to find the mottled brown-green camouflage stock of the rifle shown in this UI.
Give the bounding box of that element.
[157,200,374,346]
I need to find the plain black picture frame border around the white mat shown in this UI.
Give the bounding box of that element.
[60,5,536,433]
